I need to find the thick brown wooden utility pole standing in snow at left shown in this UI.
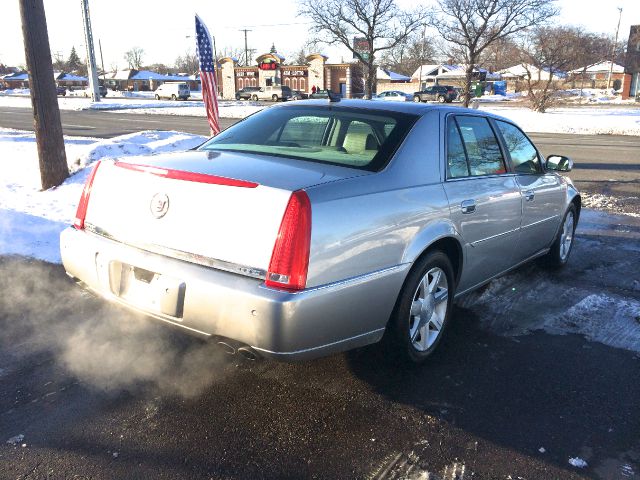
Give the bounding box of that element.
[20,0,69,190]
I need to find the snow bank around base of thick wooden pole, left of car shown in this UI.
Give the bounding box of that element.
[0,129,206,262]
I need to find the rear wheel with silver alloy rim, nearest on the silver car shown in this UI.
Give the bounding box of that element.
[387,251,455,364]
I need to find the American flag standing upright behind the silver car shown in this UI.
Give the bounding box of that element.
[196,15,220,135]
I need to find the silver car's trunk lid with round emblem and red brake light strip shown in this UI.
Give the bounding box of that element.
[85,151,370,277]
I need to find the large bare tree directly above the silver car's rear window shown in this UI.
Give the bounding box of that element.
[299,0,427,97]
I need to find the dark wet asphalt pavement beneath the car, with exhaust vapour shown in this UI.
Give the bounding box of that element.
[0,214,640,480]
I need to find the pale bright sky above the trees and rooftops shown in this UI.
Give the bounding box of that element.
[0,0,640,69]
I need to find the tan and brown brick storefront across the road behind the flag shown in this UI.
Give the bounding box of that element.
[219,49,364,99]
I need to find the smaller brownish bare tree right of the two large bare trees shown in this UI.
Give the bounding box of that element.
[522,27,575,113]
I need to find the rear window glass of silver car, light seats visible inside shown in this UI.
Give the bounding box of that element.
[200,106,418,171]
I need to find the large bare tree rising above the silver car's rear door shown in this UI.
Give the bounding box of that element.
[433,0,557,107]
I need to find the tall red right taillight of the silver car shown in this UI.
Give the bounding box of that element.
[265,190,311,291]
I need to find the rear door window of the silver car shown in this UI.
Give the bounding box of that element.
[456,115,507,176]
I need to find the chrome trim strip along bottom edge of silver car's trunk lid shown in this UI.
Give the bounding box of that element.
[85,223,267,280]
